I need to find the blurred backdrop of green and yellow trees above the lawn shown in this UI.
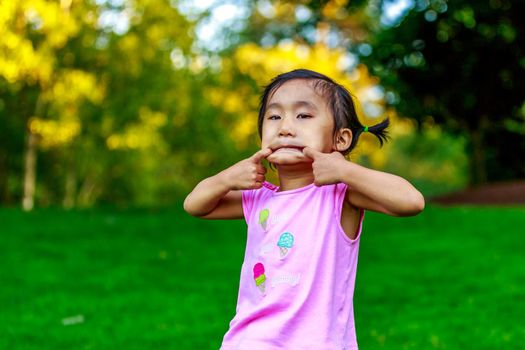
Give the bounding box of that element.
[0,0,525,208]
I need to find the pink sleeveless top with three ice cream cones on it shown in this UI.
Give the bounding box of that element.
[221,182,364,350]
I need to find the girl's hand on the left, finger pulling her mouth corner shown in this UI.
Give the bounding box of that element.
[221,148,272,190]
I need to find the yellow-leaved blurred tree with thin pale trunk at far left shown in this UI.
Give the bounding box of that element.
[0,0,100,210]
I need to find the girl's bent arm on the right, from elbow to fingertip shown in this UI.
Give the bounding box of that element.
[303,147,425,216]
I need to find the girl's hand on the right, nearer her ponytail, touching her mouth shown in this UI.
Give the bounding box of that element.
[303,147,347,186]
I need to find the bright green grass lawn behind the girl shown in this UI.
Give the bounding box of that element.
[0,206,525,350]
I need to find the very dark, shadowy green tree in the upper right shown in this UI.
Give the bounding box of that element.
[361,0,525,184]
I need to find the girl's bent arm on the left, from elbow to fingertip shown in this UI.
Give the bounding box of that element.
[184,149,272,219]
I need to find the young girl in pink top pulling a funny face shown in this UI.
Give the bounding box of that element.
[184,69,425,350]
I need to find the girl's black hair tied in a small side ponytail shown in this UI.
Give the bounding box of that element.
[257,69,390,155]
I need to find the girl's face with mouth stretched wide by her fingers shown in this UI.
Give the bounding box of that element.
[261,79,334,165]
